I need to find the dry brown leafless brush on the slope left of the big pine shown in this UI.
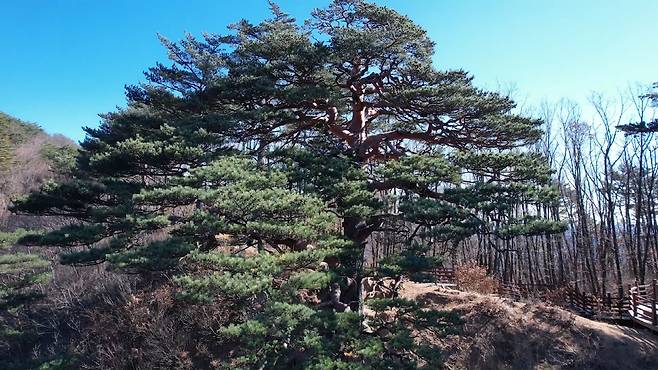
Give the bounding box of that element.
[0,264,234,369]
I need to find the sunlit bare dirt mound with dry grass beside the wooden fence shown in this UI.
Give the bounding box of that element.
[401,282,658,369]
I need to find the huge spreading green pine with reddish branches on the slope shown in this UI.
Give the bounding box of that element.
[15,0,559,368]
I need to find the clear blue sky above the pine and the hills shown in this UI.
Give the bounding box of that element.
[0,0,658,140]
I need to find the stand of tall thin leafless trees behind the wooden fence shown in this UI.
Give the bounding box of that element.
[410,85,658,295]
